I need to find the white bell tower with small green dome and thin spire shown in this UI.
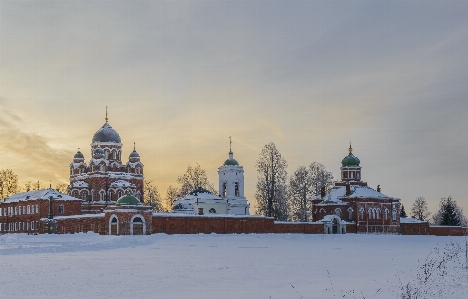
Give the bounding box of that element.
[218,137,250,215]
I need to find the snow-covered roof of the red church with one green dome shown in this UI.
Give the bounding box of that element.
[314,185,396,204]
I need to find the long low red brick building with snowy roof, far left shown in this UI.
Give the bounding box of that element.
[0,189,81,233]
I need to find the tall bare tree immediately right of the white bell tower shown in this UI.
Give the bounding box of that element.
[255,142,288,220]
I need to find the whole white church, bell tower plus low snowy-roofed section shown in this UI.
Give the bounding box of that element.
[171,145,250,215]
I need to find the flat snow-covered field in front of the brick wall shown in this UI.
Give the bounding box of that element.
[0,234,468,299]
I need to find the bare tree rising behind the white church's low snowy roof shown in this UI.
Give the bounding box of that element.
[177,164,218,197]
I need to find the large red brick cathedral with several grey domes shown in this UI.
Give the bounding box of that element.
[68,116,144,213]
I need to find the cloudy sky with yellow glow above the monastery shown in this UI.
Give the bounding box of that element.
[0,0,468,214]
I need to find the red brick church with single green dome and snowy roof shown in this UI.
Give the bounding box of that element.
[312,145,400,233]
